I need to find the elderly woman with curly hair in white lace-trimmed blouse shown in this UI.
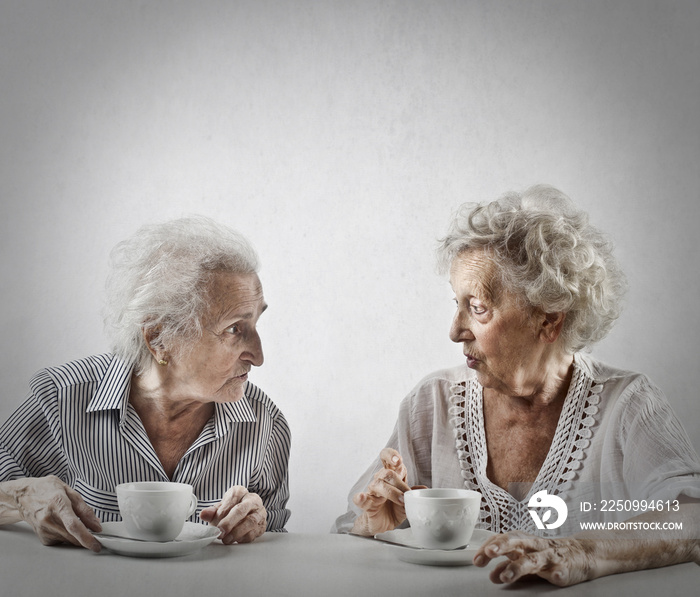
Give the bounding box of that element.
[335,186,700,585]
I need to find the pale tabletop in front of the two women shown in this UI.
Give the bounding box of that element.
[0,523,700,597]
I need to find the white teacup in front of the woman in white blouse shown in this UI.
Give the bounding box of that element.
[404,489,481,549]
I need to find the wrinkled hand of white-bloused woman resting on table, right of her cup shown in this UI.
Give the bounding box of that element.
[474,531,598,587]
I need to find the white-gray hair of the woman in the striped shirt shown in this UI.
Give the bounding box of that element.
[104,216,258,373]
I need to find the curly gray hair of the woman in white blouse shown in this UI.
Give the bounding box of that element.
[438,185,627,352]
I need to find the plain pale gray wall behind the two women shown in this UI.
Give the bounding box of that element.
[0,0,700,532]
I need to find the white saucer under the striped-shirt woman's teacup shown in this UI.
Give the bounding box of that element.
[94,522,220,558]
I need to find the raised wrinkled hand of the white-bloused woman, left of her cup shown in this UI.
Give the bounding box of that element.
[351,448,424,537]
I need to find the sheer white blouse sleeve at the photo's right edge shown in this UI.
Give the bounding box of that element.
[622,377,700,500]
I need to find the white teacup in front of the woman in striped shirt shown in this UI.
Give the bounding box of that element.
[117,481,197,541]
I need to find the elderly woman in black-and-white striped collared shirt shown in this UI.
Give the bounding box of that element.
[0,217,290,551]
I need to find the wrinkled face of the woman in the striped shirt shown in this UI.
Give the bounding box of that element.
[168,273,267,402]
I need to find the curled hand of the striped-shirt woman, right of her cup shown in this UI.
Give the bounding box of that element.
[199,485,267,545]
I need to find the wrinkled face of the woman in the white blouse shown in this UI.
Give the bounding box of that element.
[450,250,544,396]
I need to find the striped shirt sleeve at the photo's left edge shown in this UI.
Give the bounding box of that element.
[0,371,68,482]
